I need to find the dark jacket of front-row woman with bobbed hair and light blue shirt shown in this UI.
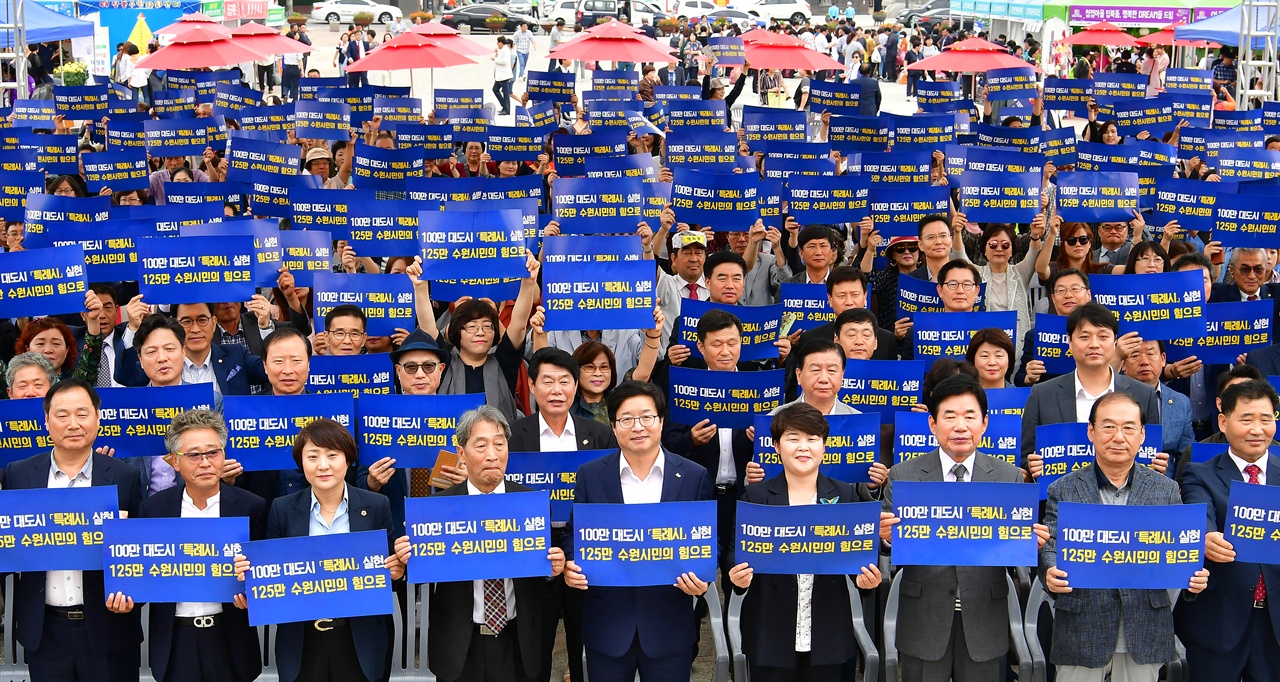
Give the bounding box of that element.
[266,485,397,682]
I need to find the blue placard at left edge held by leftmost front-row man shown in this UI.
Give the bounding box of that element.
[0,485,120,573]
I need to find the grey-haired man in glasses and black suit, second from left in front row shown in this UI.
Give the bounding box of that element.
[121,409,266,682]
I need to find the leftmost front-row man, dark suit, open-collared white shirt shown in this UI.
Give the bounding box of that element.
[4,379,142,682]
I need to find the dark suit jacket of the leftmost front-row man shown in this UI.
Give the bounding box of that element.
[4,453,142,656]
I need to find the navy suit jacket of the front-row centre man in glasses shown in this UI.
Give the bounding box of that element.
[564,450,718,658]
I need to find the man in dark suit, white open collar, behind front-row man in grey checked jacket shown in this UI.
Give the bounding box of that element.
[1021,303,1167,468]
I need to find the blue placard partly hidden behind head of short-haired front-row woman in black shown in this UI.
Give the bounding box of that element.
[753,415,881,484]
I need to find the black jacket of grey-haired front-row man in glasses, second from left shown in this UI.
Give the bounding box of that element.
[138,484,266,679]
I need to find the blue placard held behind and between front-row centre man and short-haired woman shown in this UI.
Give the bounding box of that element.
[668,366,786,429]
